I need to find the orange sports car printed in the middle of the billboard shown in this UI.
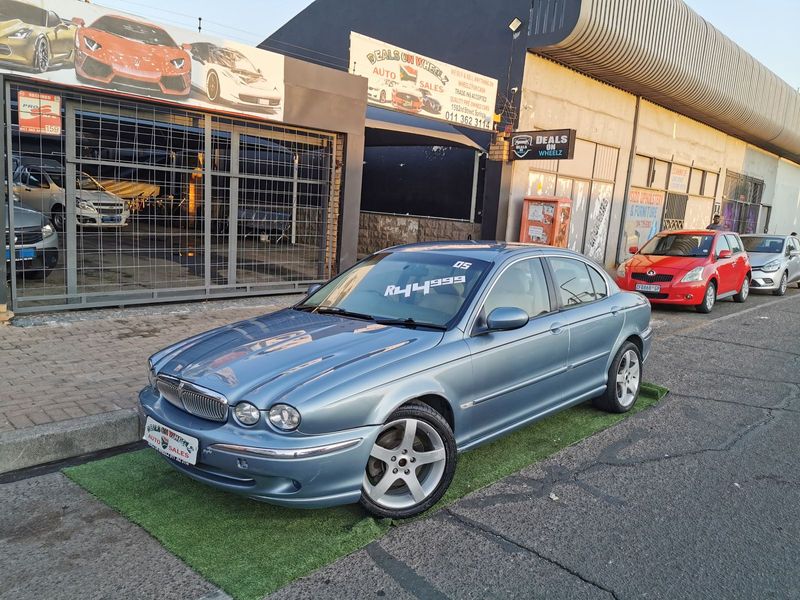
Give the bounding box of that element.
[75,15,192,97]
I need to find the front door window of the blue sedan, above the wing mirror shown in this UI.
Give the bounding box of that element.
[483,258,550,318]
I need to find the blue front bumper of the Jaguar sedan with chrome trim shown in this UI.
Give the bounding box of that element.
[139,387,380,508]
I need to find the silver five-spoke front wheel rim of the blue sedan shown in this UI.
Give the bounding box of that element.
[363,419,447,509]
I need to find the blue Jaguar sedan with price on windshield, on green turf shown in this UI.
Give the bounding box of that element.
[139,242,652,518]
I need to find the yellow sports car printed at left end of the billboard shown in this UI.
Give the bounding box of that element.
[0,0,77,73]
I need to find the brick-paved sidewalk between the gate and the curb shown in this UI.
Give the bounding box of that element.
[0,296,299,438]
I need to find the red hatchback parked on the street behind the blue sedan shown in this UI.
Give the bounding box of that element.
[616,229,750,313]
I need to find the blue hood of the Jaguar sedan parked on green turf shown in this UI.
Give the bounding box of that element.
[156,309,443,409]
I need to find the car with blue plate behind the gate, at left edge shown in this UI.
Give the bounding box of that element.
[5,202,58,278]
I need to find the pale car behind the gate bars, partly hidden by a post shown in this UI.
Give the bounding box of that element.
[14,158,131,231]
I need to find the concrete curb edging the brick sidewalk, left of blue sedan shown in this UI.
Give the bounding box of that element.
[0,408,139,474]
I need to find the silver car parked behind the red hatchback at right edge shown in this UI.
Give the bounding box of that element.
[741,234,800,296]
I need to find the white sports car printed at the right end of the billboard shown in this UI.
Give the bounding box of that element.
[189,42,281,110]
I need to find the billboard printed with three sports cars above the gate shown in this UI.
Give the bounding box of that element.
[0,0,284,121]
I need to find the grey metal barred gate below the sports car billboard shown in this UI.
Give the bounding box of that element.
[6,83,342,312]
